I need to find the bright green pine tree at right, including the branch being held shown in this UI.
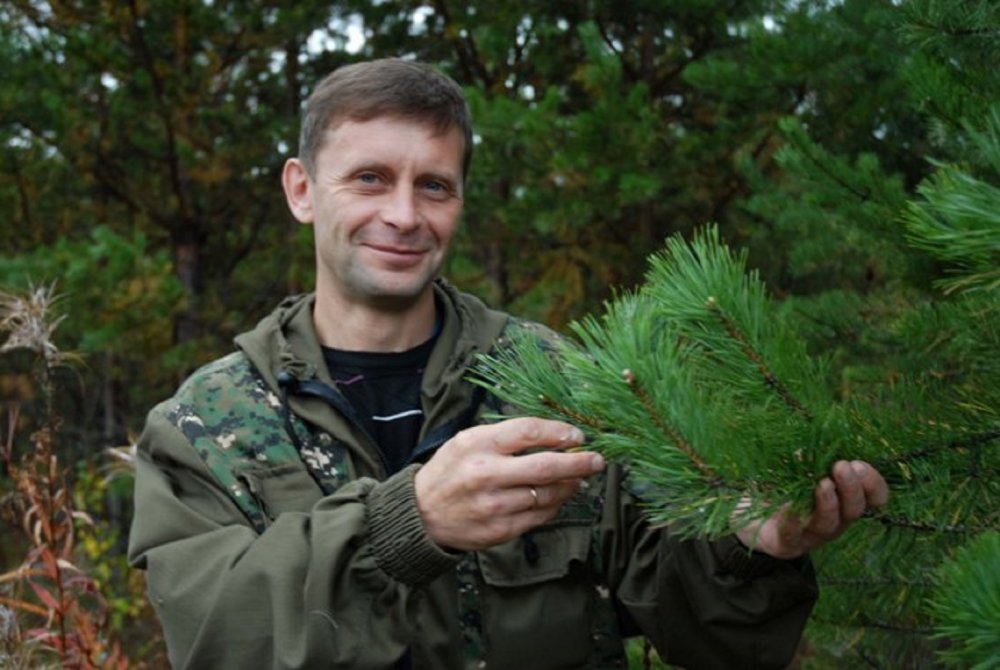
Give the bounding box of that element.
[479,1,1000,668]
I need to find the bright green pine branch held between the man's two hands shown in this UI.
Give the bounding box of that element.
[480,229,1000,536]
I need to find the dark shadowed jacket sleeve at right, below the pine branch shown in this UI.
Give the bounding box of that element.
[602,474,818,670]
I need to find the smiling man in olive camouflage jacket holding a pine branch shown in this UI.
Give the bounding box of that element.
[130,60,887,670]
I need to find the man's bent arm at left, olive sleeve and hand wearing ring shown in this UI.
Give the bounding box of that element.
[129,411,604,668]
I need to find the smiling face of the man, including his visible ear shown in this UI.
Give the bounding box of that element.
[284,117,464,311]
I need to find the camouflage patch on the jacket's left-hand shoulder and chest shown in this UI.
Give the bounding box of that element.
[167,352,349,532]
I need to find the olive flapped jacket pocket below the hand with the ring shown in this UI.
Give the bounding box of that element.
[479,522,595,670]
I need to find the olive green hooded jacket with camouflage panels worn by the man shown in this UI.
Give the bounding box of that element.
[129,281,816,670]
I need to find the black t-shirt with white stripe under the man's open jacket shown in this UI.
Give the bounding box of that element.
[323,332,437,475]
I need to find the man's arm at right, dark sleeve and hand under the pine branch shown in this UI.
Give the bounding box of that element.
[604,463,888,669]
